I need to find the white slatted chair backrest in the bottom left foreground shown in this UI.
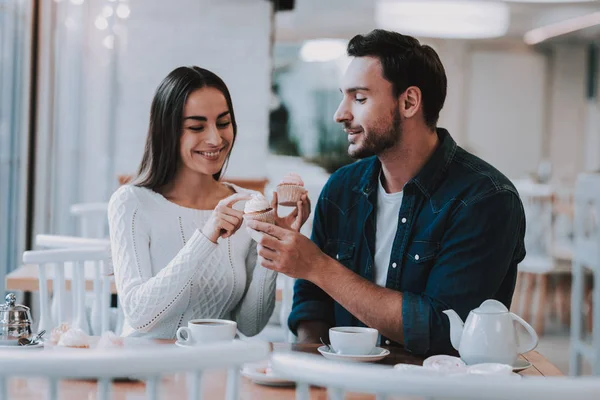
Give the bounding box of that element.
[0,340,269,400]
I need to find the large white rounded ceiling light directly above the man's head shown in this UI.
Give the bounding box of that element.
[375,0,510,39]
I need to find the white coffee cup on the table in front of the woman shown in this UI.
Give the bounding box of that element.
[175,319,237,346]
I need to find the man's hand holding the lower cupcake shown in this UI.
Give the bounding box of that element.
[248,220,328,283]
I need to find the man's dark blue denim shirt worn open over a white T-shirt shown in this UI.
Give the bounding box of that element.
[288,128,525,355]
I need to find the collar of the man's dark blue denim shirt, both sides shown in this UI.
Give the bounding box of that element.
[352,128,457,198]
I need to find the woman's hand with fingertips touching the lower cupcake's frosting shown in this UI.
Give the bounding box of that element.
[202,193,250,243]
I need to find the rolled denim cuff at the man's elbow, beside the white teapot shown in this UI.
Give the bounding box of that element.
[402,292,431,354]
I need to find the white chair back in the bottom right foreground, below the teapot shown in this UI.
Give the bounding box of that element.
[271,353,600,400]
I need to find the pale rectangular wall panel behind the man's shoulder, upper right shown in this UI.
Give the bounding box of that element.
[466,51,546,177]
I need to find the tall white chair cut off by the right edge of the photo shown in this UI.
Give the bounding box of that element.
[569,174,600,375]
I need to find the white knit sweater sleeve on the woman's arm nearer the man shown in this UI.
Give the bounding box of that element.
[233,240,277,336]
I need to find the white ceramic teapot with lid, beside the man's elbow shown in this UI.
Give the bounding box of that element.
[444,300,538,365]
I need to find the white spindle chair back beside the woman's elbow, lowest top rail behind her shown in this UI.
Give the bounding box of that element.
[23,247,111,333]
